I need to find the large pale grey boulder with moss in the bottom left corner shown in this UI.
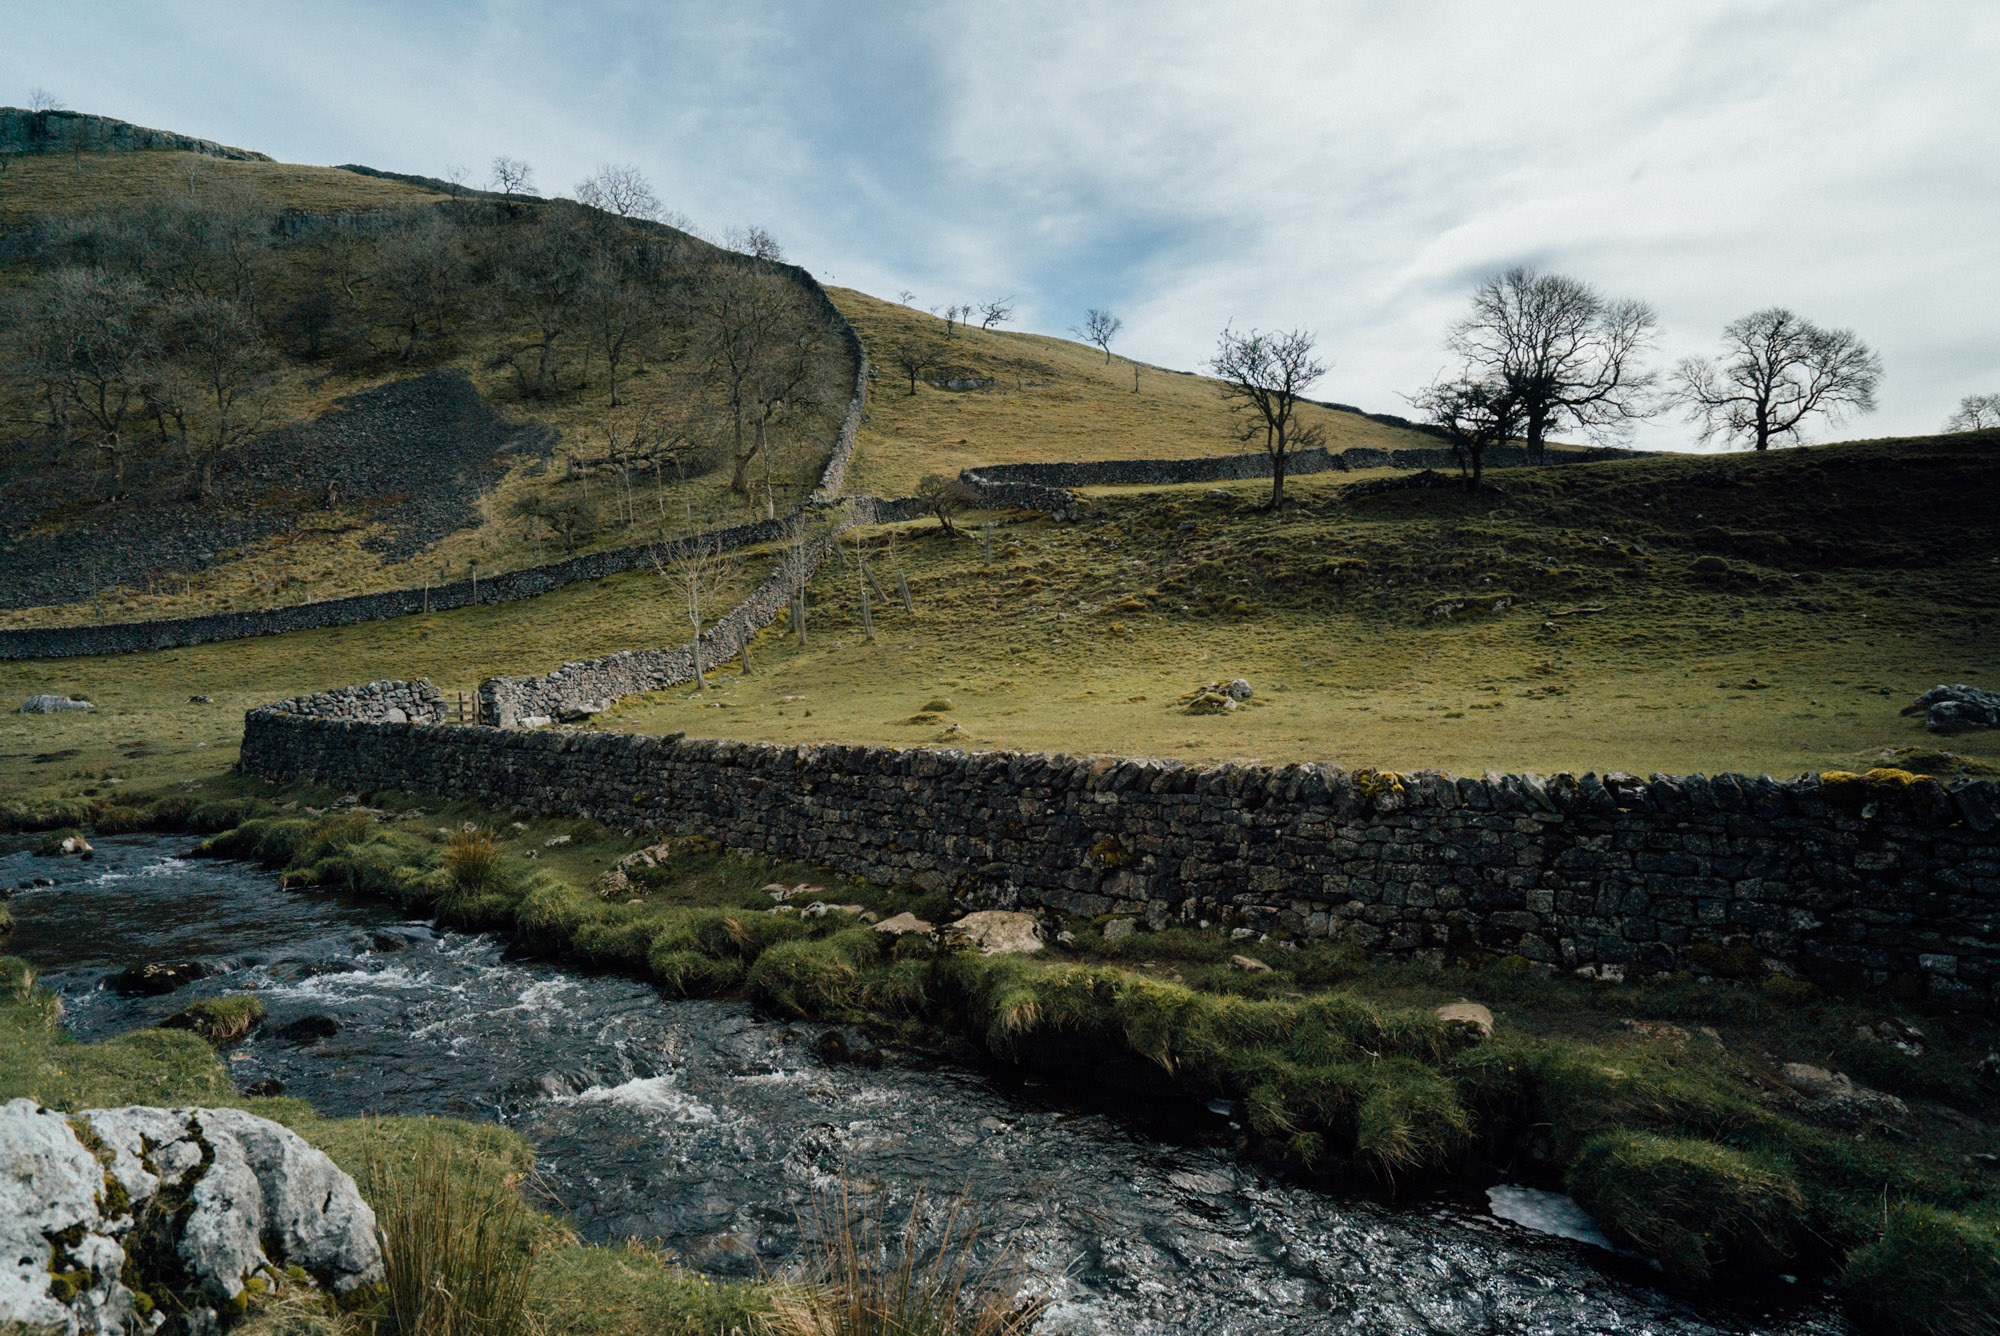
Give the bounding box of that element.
[0,1100,382,1336]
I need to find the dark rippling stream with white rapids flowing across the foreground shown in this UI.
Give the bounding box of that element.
[0,836,1848,1336]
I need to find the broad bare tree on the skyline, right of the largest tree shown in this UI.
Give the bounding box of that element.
[1670,306,1882,450]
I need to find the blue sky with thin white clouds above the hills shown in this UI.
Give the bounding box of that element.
[0,0,2000,448]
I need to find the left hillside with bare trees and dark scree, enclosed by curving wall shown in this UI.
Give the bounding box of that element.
[0,141,852,624]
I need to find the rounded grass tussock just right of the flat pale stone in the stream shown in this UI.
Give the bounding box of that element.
[1564,1132,1806,1284]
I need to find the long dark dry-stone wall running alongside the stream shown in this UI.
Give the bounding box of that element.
[242,708,2000,1014]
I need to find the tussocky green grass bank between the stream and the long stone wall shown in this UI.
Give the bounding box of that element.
[3,790,1994,1330]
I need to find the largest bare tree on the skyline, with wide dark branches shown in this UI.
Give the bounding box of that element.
[1446,266,1658,460]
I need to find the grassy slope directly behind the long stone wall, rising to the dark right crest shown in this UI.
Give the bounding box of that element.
[600,438,2000,774]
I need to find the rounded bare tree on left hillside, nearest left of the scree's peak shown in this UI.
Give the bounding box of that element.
[146,296,276,496]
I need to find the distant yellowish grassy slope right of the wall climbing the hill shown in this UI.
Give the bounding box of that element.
[828,288,1438,496]
